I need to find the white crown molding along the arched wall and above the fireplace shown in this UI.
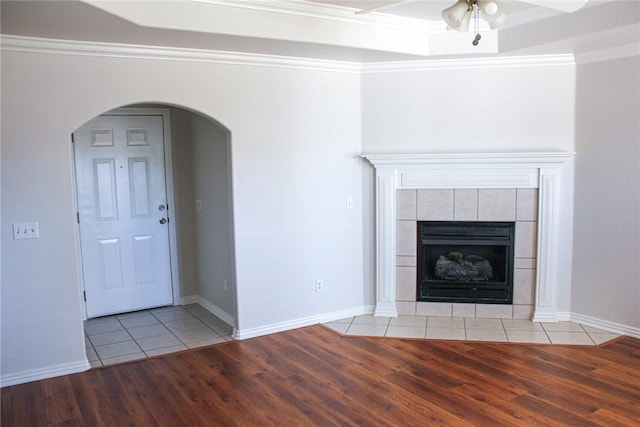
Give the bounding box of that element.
[0,34,575,74]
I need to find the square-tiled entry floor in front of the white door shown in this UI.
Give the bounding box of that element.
[84,304,233,367]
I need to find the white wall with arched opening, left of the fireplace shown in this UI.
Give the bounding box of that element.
[0,46,364,379]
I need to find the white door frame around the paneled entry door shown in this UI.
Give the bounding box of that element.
[71,107,181,320]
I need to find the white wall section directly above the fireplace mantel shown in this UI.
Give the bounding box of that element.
[362,58,575,154]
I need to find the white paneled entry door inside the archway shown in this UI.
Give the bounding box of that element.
[74,115,173,317]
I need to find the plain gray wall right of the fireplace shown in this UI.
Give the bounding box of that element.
[572,56,640,334]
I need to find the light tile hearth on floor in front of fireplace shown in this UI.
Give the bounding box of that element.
[324,315,620,345]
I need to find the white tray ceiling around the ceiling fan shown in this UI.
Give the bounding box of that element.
[0,0,640,63]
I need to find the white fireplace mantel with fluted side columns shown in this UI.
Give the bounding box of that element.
[362,152,575,322]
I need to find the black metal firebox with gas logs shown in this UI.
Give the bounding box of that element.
[417,221,515,304]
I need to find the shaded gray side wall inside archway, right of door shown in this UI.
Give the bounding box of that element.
[171,108,236,317]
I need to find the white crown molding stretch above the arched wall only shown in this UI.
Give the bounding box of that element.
[0,35,361,73]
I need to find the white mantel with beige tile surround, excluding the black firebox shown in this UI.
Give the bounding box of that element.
[363,152,574,322]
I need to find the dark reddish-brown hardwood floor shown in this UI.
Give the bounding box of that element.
[1,325,640,427]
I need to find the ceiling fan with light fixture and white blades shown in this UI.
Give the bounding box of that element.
[356,0,588,46]
